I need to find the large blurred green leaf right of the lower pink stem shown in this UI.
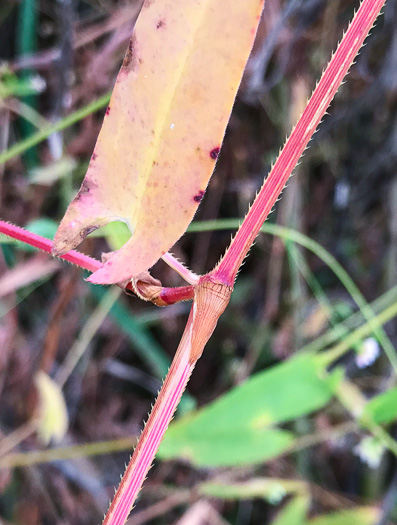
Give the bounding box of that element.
[159,354,340,467]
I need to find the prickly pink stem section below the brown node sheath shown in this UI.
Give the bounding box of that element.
[103,308,195,525]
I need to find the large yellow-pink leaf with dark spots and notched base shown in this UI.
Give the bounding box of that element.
[54,0,264,284]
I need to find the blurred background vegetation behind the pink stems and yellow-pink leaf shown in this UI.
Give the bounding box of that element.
[0,0,397,525]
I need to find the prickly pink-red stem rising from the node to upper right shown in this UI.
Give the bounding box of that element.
[213,0,385,285]
